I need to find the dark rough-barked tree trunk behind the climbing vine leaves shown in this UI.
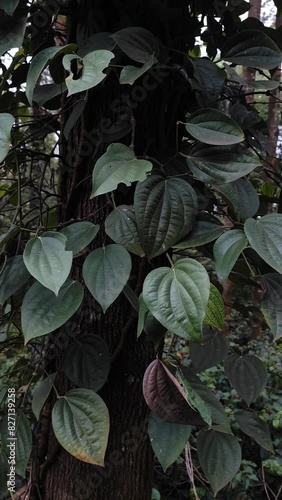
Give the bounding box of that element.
[33,0,192,500]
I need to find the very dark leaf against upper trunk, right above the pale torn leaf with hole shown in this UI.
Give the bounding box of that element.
[111,27,160,63]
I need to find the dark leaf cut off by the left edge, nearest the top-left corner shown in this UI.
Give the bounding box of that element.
[0,9,26,56]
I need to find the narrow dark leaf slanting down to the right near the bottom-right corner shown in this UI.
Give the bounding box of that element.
[234,410,274,453]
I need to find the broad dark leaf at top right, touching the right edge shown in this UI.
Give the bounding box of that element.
[221,30,282,69]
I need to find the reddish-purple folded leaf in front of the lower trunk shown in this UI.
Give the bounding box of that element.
[143,359,204,425]
